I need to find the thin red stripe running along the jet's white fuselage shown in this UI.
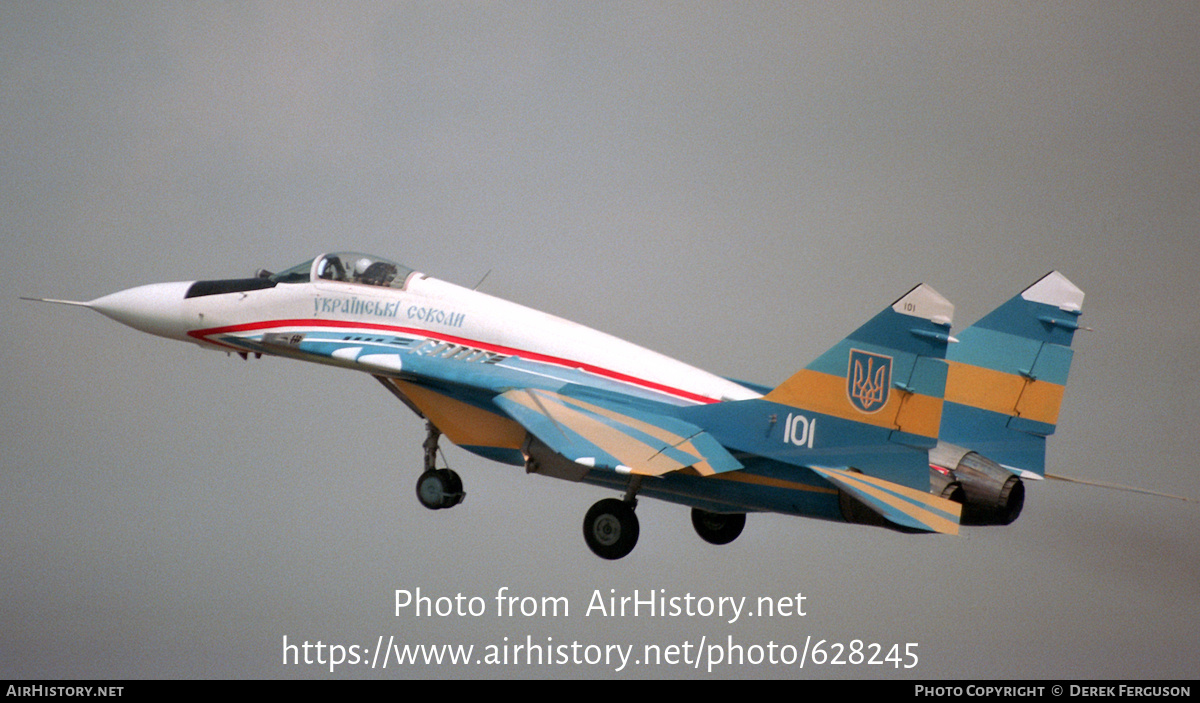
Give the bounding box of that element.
[187,319,718,403]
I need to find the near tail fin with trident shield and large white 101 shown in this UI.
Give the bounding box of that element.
[682,284,954,491]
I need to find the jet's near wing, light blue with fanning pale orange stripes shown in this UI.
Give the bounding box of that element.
[494,389,742,476]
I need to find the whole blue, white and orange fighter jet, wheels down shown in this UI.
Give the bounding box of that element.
[18,252,1084,559]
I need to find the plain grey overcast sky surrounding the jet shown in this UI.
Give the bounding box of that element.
[7,2,1200,679]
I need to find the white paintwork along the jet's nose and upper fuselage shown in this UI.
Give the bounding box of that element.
[75,261,760,402]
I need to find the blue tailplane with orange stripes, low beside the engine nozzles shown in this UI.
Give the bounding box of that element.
[809,467,962,535]
